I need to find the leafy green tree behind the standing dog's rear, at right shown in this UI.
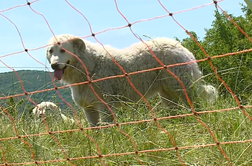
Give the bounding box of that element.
[181,6,252,102]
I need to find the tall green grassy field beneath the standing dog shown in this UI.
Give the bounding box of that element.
[0,98,252,166]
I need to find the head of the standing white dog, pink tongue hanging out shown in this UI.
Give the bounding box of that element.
[46,35,86,80]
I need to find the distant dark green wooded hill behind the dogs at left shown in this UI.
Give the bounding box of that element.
[0,70,73,109]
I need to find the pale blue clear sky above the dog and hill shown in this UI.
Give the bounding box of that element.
[0,0,245,73]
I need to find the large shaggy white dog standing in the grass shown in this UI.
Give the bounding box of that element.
[47,35,217,126]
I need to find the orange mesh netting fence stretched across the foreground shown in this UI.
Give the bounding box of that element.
[0,0,252,165]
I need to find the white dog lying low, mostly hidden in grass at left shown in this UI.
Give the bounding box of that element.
[32,101,74,123]
